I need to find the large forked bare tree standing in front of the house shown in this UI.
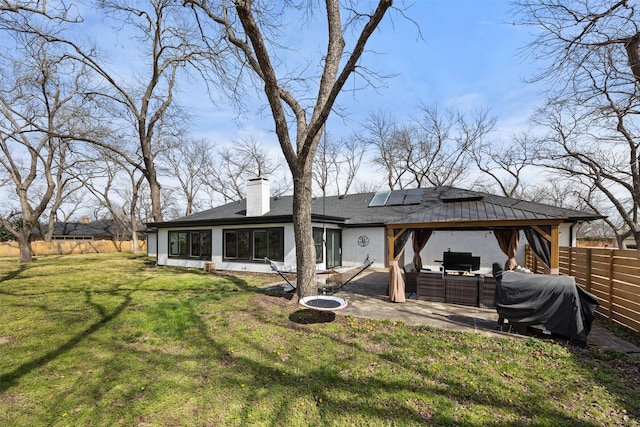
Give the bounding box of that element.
[186,0,392,296]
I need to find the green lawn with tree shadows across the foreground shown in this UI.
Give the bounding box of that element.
[0,255,640,426]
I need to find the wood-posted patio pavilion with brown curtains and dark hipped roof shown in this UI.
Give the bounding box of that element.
[386,193,598,302]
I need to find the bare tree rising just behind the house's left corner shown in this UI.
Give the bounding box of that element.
[23,0,232,221]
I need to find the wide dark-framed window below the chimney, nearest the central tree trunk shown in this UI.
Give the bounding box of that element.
[223,228,284,261]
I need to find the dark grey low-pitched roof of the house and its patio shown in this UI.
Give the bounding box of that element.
[149,187,601,227]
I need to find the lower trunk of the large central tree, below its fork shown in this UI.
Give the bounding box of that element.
[293,173,318,298]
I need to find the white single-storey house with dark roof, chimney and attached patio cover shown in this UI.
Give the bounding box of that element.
[148,178,600,272]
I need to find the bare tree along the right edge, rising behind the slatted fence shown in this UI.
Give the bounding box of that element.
[518,0,640,247]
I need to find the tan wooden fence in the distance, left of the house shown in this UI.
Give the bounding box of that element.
[0,240,147,257]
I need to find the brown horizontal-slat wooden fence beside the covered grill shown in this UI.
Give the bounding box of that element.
[526,247,640,332]
